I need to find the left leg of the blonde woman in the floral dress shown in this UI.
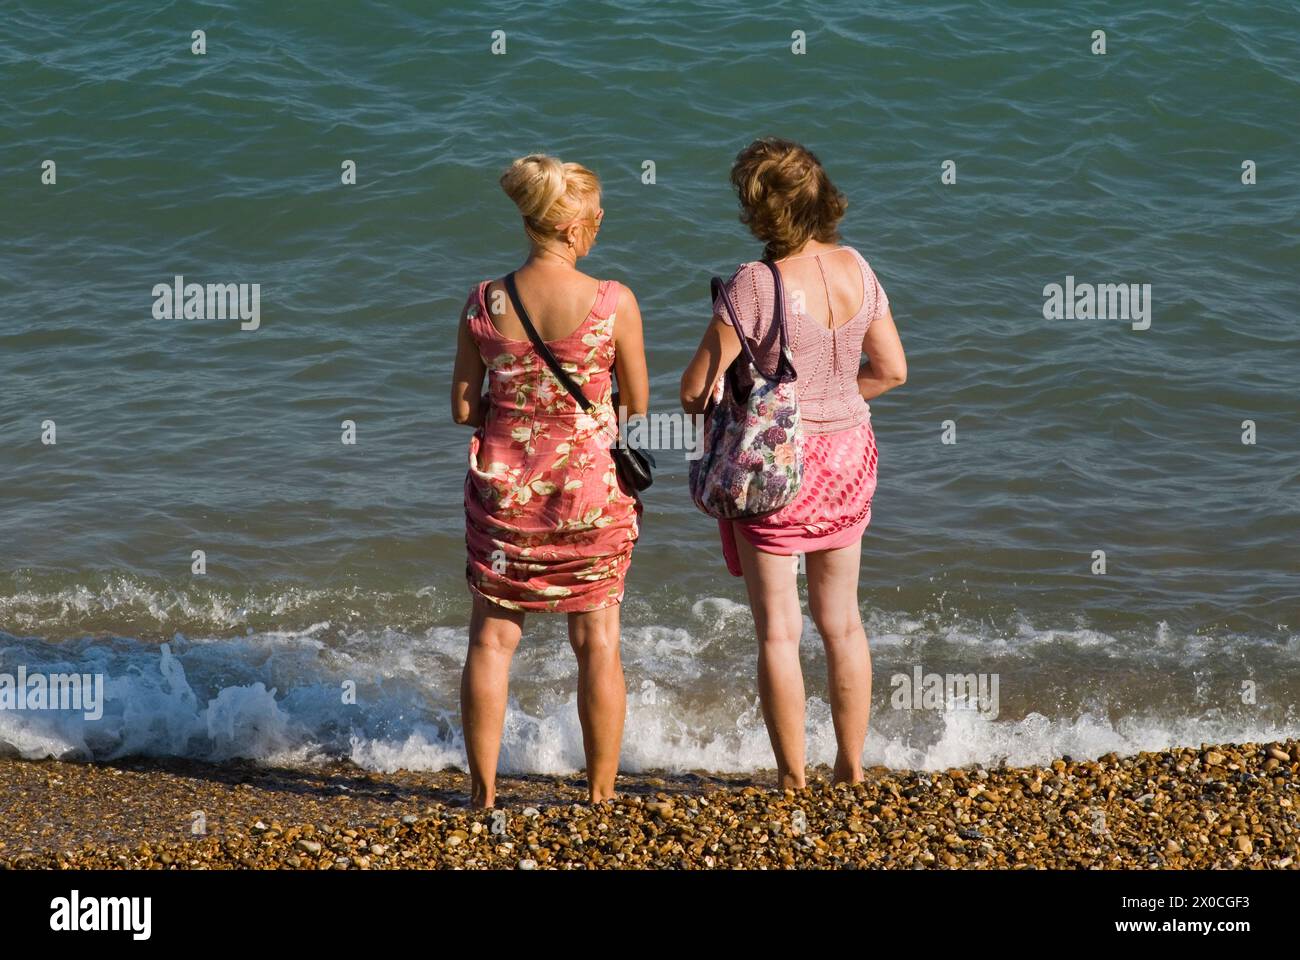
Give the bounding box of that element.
[460,594,524,807]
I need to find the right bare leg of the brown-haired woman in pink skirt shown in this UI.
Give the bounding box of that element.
[807,539,871,783]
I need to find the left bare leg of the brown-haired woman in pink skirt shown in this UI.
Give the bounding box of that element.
[736,531,805,790]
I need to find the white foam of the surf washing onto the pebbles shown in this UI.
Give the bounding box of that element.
[0,616,1300,774]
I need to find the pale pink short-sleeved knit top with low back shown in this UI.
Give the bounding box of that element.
[714,247,889,433]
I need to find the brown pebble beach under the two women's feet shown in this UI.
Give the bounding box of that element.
[0,740,1300,869]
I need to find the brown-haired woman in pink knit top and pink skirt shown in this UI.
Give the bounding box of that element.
[681,138,907,787]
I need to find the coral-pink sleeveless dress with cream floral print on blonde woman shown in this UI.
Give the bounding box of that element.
[465,280,641,613]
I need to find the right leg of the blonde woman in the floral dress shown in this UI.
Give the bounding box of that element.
[569,604,628,804]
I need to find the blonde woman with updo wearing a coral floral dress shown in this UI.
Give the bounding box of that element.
[451,155,649,807]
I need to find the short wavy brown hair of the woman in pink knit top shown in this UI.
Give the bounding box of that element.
[731,137,849,260]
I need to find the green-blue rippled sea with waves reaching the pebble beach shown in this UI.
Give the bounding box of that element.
[0,0,1300,773]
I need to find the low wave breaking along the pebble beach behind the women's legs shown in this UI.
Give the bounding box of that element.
[0,598,1300,774]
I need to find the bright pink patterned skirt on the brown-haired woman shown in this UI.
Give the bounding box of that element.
[718,420,876,576]
